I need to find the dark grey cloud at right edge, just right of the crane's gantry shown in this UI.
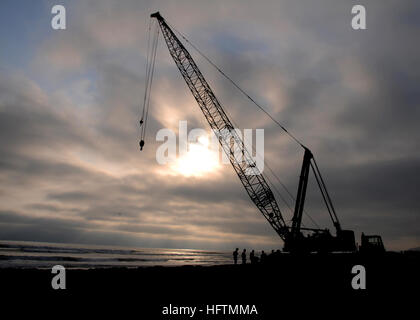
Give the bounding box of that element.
[327,158,420,215]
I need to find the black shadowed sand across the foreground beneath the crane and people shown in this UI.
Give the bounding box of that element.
[0,253,420,319]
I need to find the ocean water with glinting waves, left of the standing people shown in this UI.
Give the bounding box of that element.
[0,241,232,269]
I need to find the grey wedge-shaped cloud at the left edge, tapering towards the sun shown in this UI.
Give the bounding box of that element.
[0,72,92,156]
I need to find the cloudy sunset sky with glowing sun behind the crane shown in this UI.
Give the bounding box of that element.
[0,0,420,250]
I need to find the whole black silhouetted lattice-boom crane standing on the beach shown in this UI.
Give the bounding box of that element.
[147,12,384,252]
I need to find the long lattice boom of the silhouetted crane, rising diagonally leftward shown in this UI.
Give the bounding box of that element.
[151,12,289,241]
